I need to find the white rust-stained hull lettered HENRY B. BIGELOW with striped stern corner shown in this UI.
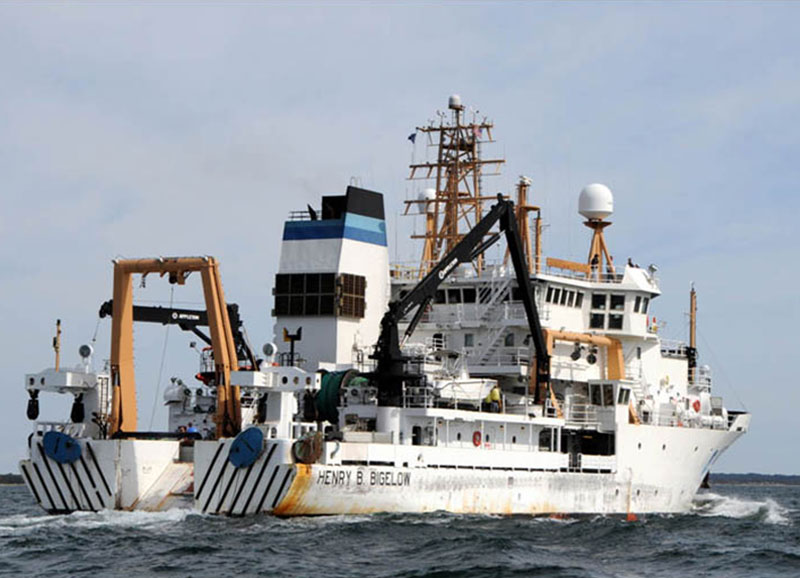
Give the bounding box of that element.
[195,416,749,516]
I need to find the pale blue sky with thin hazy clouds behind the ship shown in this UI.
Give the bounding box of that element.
[0,2,800,474]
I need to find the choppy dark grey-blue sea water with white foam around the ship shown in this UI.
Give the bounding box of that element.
[0,484,800,578]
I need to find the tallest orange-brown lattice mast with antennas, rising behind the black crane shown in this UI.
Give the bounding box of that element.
[406,95,505,277]
